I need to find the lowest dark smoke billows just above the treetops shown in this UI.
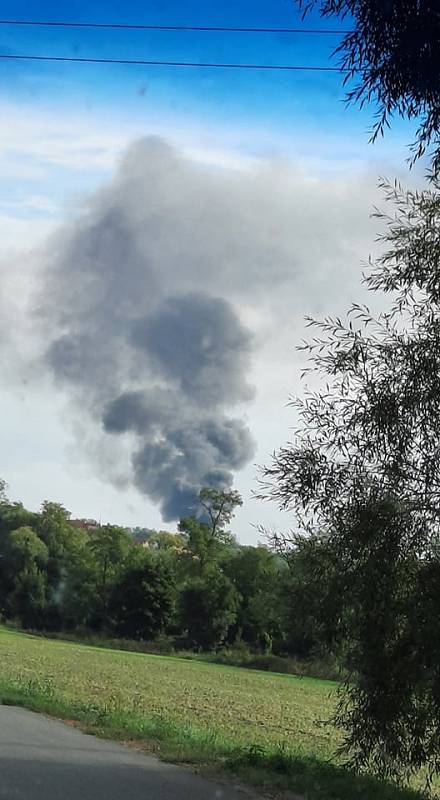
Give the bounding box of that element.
[104,391,253,520]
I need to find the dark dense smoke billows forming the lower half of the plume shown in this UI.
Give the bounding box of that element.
[103,293,254,520]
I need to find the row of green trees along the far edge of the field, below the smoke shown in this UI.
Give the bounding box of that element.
[0,490,328,657]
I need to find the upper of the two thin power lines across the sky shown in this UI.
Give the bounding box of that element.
[0,19,352,36]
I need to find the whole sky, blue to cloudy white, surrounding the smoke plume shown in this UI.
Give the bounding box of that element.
[0,0,421,542]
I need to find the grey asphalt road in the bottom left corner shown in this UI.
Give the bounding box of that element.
[0,705,252,800]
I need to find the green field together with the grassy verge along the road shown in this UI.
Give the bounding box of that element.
[0,629,426,800]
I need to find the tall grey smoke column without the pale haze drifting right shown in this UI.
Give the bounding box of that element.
[40,139,254,521]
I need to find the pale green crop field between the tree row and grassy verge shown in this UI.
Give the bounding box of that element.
[0,630,336,757]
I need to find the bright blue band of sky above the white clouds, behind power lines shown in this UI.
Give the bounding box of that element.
[0,0,410,159]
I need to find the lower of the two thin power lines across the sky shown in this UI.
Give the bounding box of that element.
[0,53,349,72]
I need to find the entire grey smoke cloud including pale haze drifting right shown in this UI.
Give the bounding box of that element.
[39,138,374,521]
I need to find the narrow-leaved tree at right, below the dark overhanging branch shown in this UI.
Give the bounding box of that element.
[263,184,440,777]
